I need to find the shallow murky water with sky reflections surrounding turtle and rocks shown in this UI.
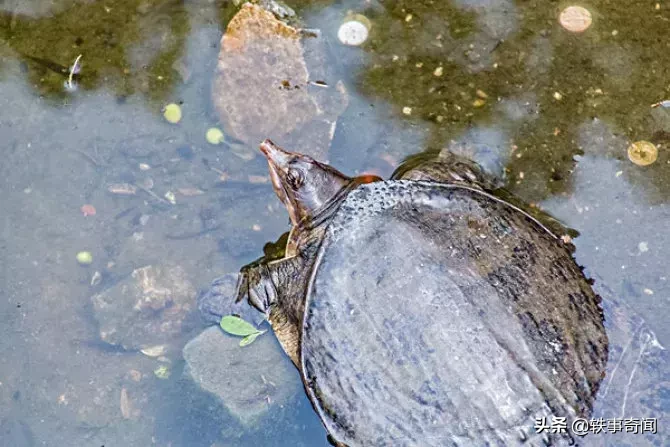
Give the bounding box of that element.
[0,0,670,446]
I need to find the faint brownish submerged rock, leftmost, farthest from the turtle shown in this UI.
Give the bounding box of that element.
[91,265,196,349]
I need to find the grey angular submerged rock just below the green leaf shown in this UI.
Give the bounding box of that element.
[183,326,301,427]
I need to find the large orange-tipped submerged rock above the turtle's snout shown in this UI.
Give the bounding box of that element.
[212,3,348,159]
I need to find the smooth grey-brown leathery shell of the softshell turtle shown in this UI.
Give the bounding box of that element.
[301,180,608,446]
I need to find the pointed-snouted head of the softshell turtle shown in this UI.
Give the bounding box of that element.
[260,140,353,225]
